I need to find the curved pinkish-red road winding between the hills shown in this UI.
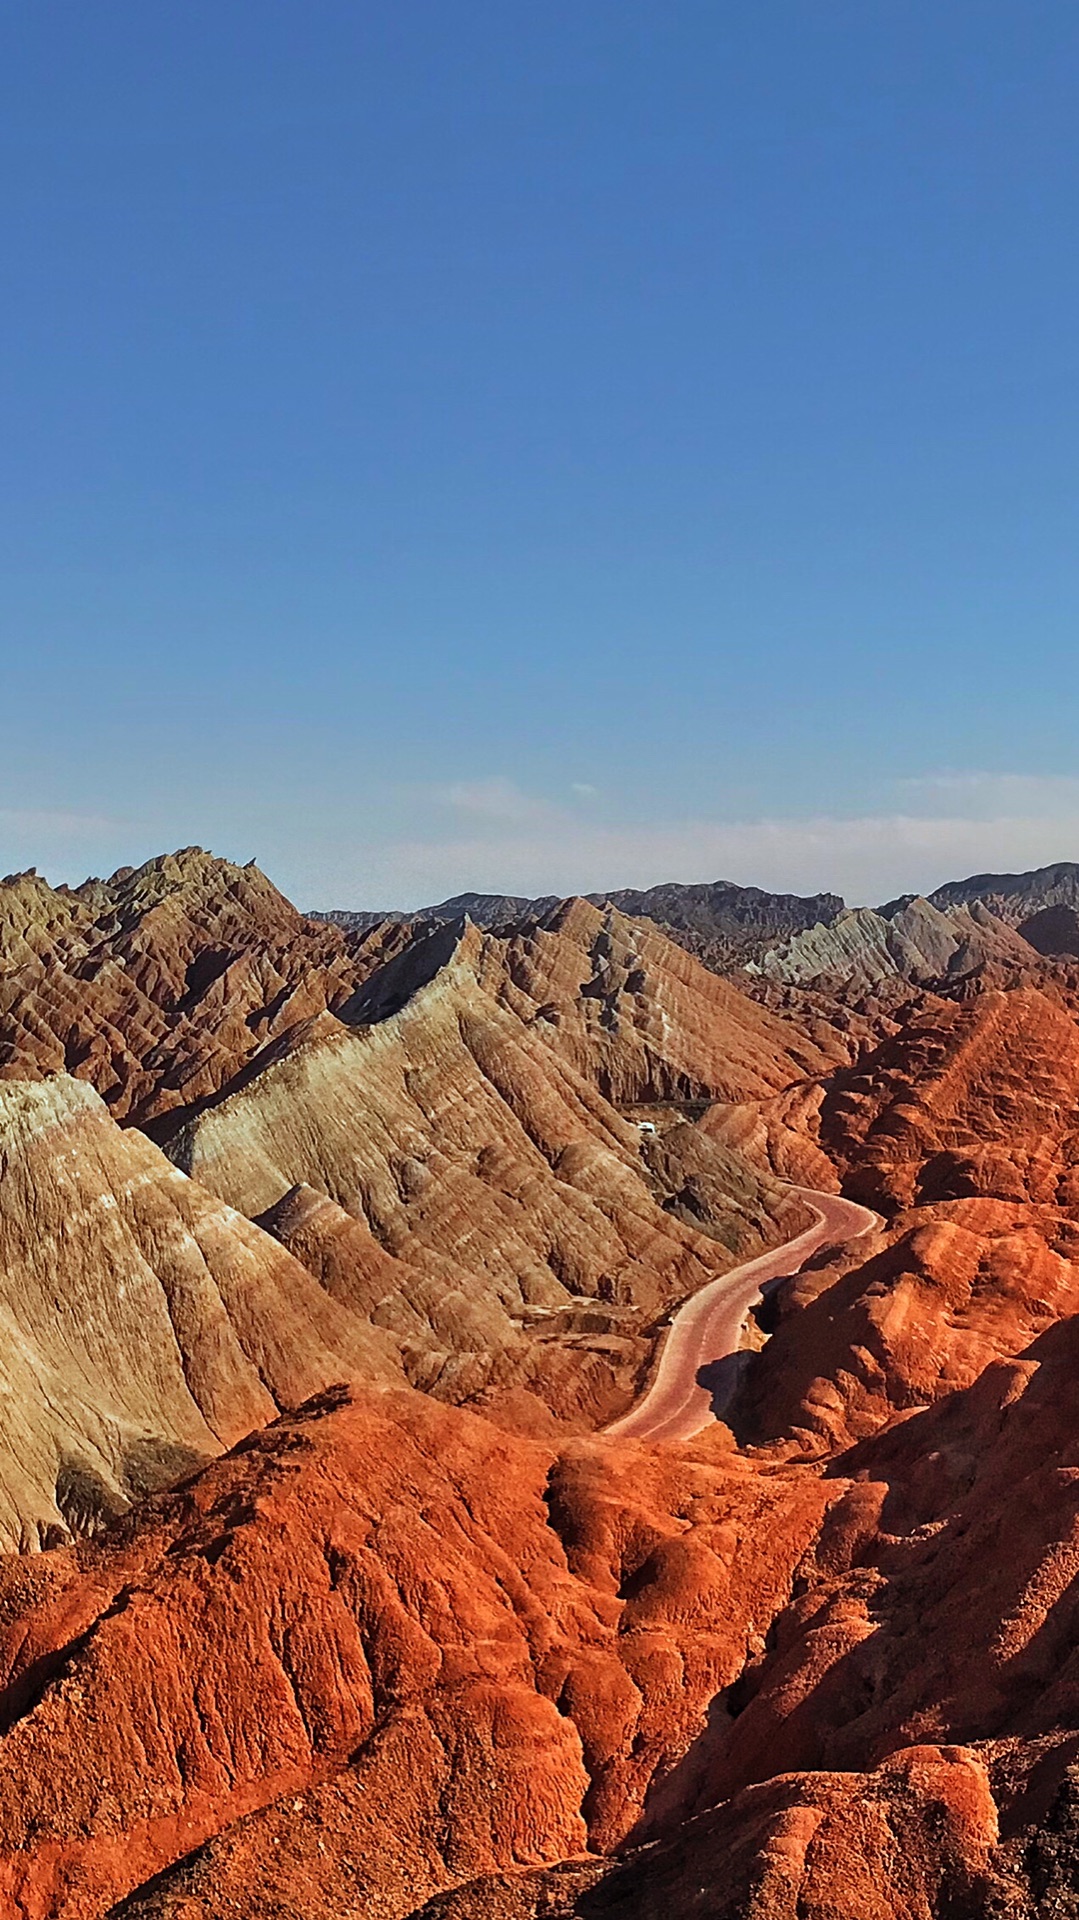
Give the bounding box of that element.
[603,1187,879,1440]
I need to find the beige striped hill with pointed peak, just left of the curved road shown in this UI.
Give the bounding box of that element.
[169,908,797,1425]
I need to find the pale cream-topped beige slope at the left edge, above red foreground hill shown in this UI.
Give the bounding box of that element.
[0,1075,401,1549]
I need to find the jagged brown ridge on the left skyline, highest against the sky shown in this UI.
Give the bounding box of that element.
[0,847,407,1127]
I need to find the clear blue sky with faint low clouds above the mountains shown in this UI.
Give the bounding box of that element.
[0,0,1079,906]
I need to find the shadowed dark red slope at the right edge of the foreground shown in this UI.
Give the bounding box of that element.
[679,1290,1079,1836]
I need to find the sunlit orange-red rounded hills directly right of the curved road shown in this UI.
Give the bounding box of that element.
[721,989,1079,1455]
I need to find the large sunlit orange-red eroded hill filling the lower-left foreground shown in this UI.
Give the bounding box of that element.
[0,1392,837,1920]
